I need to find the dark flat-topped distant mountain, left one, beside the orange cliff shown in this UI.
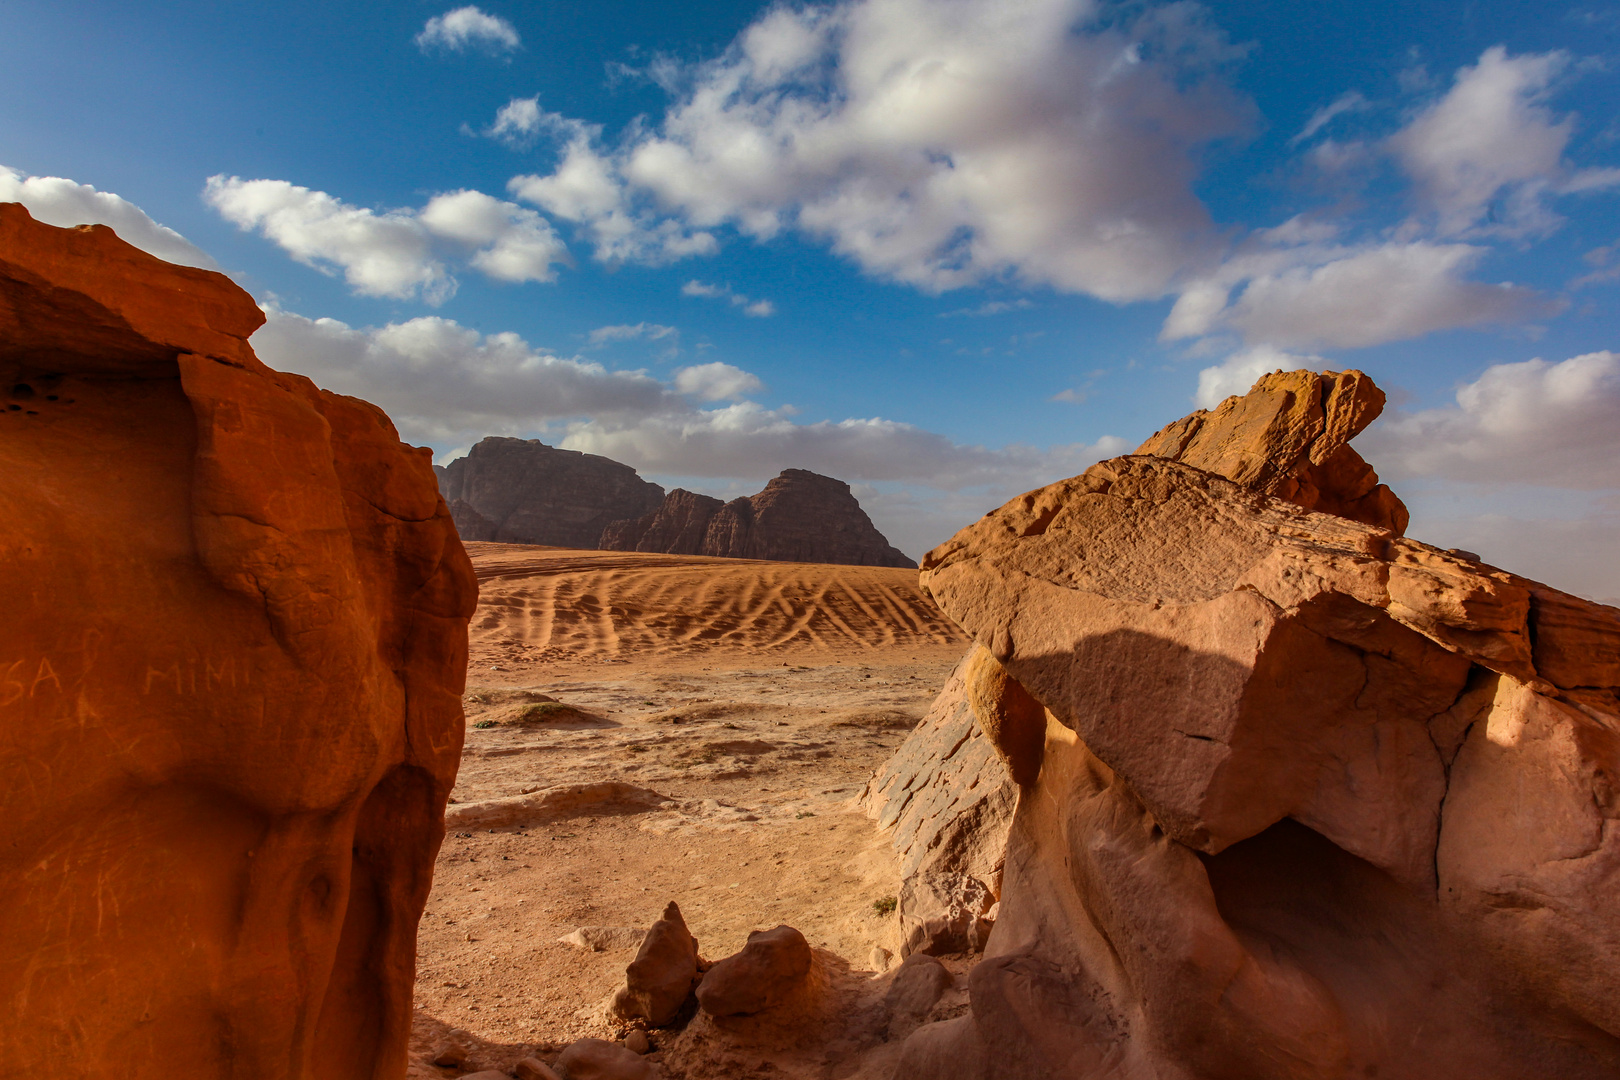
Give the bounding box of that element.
[444,436,664,547]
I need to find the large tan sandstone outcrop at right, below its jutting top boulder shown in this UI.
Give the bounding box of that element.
[896,372,1620,1080]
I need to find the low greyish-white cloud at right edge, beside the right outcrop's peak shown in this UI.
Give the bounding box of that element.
[1364,351,1620,489]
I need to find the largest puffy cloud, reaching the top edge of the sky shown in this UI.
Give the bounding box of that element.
[512,0,1247,301]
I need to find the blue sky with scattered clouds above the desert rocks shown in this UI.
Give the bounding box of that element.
[9,0,1620,597]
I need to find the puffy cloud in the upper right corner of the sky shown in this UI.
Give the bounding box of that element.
[1388,45,1620,236]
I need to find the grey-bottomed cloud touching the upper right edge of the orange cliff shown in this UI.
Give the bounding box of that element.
[253,306,673,445]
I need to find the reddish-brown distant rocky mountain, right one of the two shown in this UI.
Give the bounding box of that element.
[601,470,917,567]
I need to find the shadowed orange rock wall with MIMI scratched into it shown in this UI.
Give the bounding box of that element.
[0,204,476,1080]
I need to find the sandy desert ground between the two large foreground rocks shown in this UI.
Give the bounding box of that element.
[413,544,966,1077]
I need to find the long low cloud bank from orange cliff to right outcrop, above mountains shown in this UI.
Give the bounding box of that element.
[253,296,1129,518]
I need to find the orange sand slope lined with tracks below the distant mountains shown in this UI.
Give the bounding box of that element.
[467,544,966,662]
